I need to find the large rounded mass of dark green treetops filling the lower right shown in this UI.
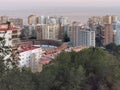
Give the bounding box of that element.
[40,48,120,90]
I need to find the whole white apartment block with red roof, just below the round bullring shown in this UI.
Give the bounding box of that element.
[19,46,42,69]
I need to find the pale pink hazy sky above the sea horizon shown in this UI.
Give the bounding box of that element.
[0,0,120,9]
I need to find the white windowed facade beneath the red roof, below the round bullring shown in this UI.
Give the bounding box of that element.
[19,48,42,68]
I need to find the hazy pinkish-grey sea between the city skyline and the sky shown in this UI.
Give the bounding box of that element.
[0,7,120,24]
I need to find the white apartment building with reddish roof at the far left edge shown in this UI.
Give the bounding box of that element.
[0,24,21,46]
